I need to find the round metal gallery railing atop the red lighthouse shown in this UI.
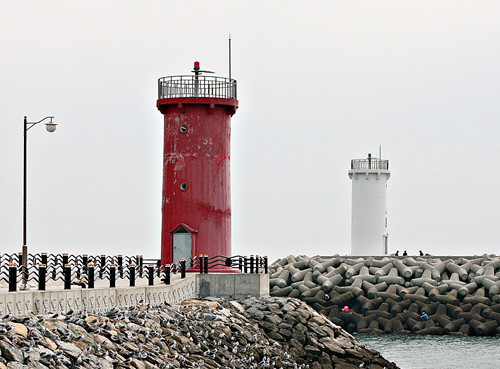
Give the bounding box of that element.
[158,76,236,99]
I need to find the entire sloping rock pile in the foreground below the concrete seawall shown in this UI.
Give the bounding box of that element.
[0,298,396,369]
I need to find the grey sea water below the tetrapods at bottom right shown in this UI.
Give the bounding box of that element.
[355,334,500,369]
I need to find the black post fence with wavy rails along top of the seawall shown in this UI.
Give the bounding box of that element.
[0,253,268,292]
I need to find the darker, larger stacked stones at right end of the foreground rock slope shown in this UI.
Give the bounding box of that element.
[236,297,397,369]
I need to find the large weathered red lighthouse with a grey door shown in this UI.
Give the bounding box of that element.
[157,62,238,265]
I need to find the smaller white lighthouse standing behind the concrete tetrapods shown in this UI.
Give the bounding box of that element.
[348,154,391,256]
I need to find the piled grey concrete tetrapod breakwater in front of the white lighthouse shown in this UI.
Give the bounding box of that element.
[269,255,500,336]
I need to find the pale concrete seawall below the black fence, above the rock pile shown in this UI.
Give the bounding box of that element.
[0,273,269,316]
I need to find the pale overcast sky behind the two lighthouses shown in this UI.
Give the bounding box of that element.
[0,0,500,259]
